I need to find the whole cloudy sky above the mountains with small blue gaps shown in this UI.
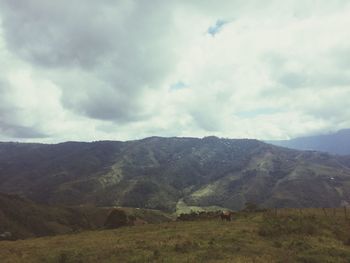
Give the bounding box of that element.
[0,0,350,143]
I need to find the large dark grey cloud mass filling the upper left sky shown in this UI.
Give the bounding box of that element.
[2,0,175,122]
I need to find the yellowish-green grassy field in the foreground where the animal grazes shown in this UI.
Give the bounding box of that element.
[0,213,350,262]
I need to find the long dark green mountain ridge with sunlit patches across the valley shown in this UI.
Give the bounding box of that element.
[0,136,350,211]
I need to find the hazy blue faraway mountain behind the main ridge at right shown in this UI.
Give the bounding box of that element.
[268,129,350,155]
